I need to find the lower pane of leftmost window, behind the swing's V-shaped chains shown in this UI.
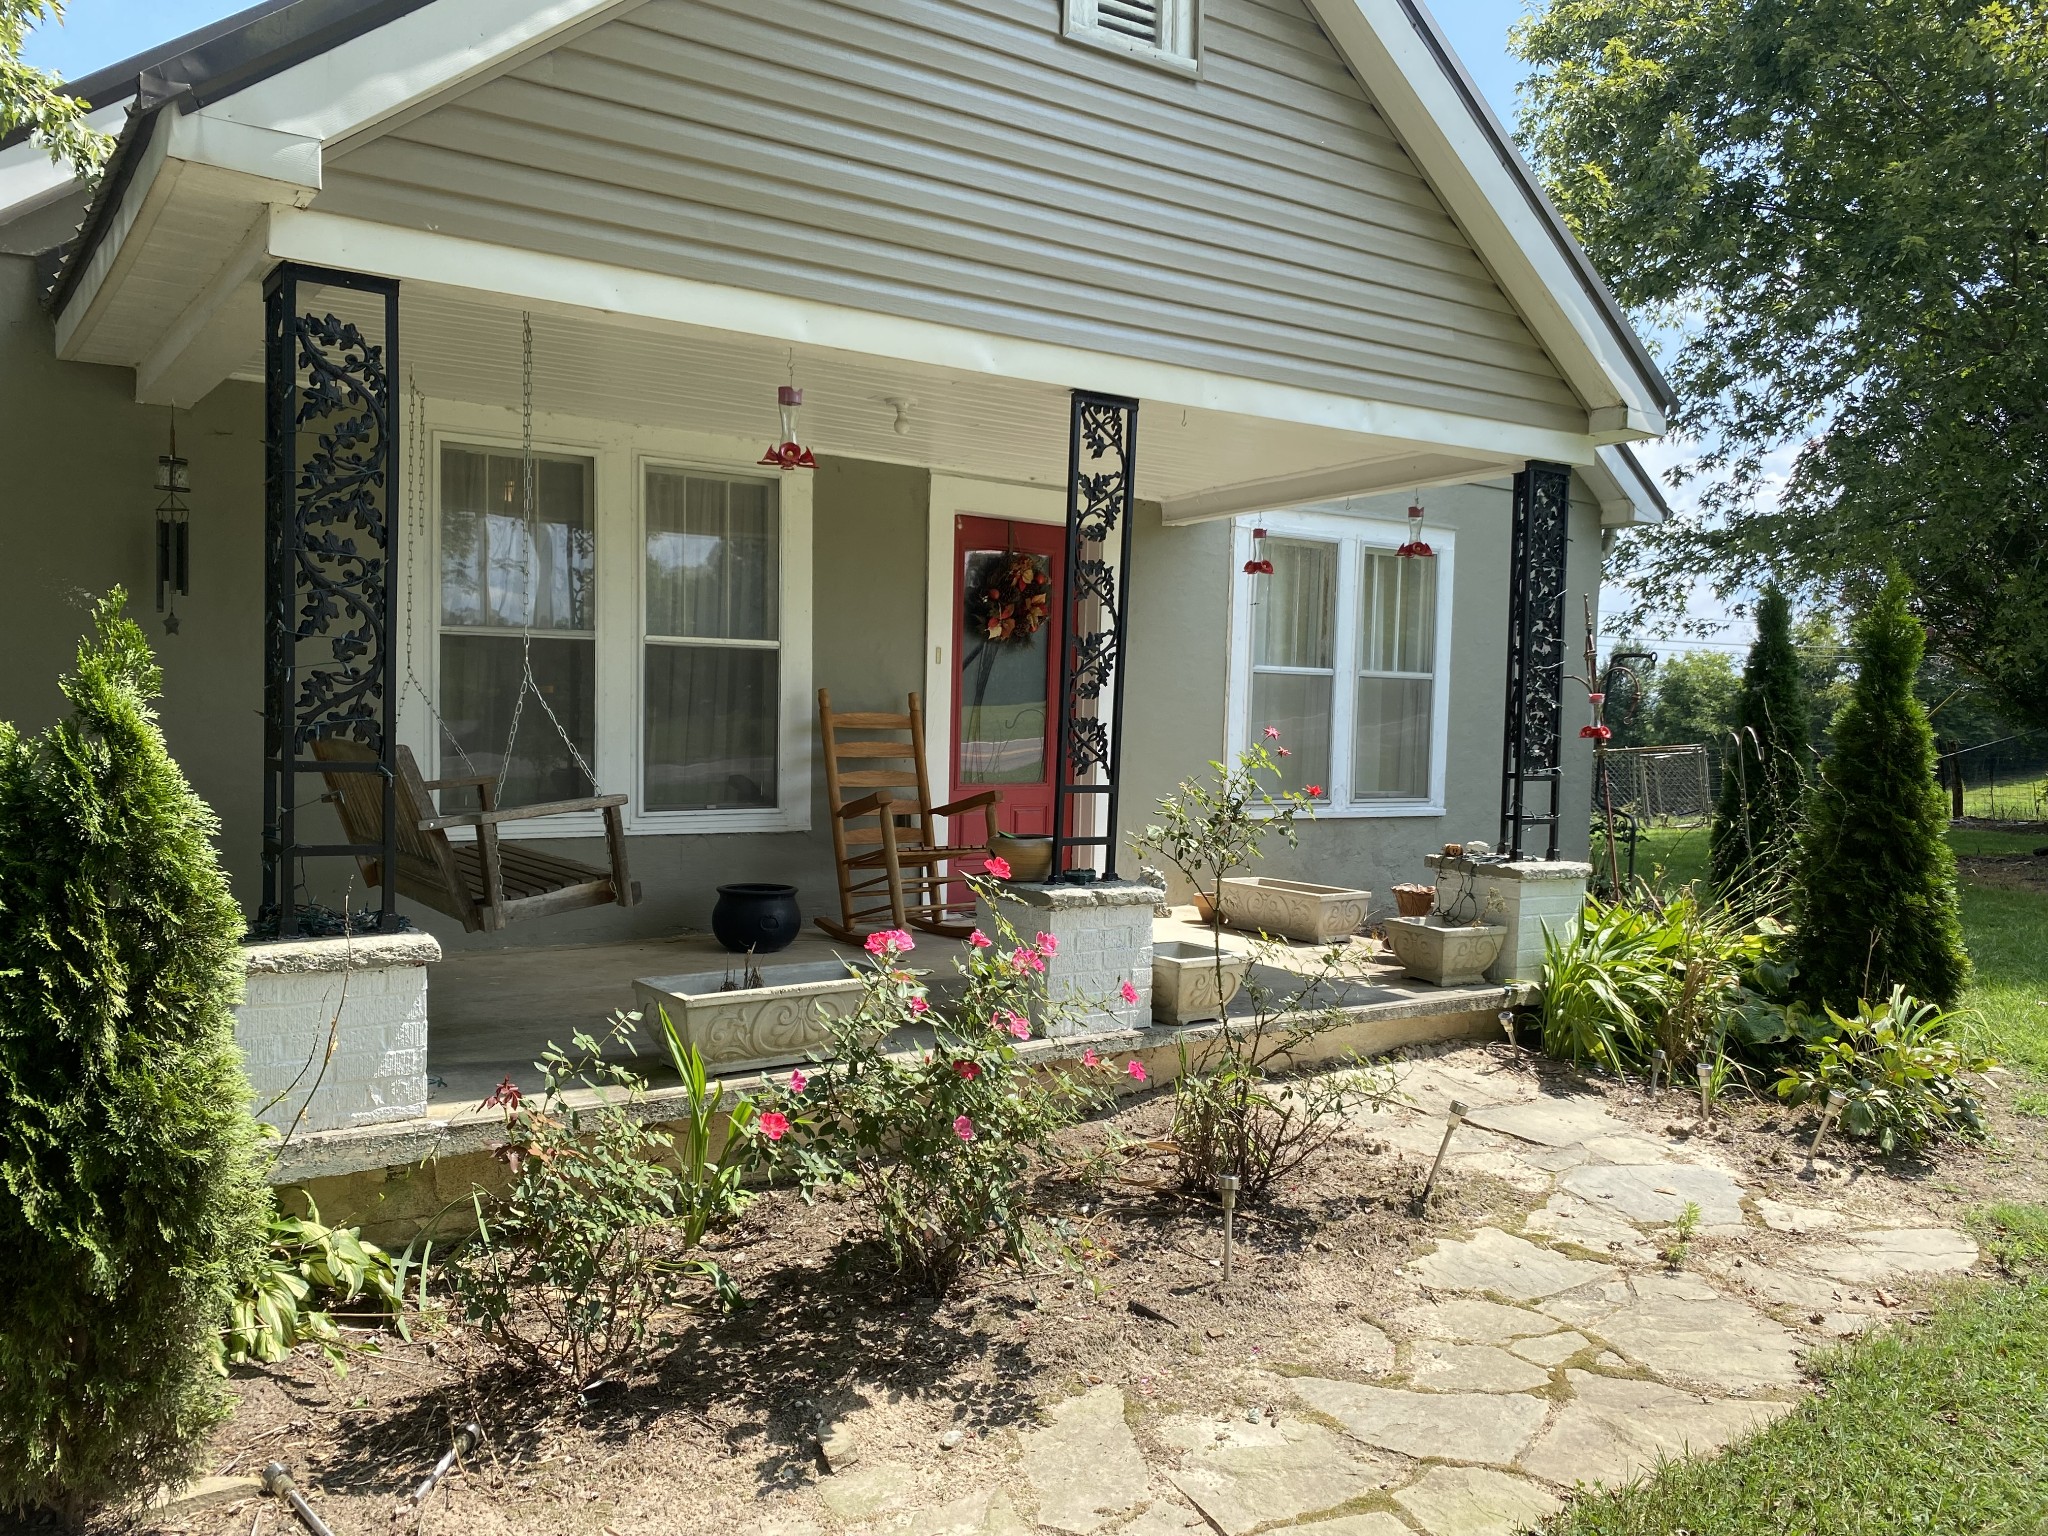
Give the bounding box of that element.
[440,633,598,811]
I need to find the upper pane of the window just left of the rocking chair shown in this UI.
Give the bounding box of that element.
[647,469,780,639]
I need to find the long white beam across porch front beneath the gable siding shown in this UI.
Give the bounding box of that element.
[270,209,1593,463]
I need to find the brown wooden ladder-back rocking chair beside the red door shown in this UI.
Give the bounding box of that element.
[817,688,1001,944]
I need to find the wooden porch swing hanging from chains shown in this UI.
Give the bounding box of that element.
[313,737,641,934]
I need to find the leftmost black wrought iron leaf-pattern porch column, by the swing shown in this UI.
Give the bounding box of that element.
[260,262,399,938]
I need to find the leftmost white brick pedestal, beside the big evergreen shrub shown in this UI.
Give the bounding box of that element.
[236,934,440,1133]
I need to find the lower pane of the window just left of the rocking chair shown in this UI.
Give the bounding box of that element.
[645,645,780,811]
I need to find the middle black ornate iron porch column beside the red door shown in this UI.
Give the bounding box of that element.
[1053,389,1139,879]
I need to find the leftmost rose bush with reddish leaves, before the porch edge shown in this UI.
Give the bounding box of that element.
[453,1018,723,1391]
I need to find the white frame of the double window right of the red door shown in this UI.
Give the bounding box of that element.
[1227,510,1458,821]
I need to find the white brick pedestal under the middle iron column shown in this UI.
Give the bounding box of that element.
[981,881,1159,1038]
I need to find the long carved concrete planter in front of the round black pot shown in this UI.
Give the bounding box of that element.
[633,961,860,1077]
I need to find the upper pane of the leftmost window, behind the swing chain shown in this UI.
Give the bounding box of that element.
[440,444,596,631]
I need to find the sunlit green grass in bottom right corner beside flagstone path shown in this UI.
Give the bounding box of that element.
[1544,1277,2048,1536]
